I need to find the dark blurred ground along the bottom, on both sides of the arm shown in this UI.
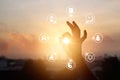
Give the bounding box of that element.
[0,57,120,80]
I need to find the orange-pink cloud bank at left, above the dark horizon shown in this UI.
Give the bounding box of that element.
[0,32,42,58]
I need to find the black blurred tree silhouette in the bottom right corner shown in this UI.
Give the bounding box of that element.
[99,57,120,80]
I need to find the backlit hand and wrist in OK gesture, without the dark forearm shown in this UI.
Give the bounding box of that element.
[63,21,87,63]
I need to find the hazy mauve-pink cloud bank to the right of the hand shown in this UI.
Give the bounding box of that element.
[83,34,120,55]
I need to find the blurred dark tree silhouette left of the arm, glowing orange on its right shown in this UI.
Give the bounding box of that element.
[22,60,48,80]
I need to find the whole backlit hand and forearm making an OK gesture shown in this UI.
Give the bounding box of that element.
[63,21,96,80]
